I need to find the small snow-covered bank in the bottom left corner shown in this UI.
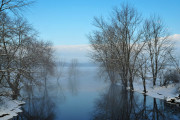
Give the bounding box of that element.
[0,97,25,120]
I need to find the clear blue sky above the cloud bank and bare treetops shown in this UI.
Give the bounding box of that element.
[25,0,180,45]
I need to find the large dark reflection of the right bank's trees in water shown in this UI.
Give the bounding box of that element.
[92,84,180,120]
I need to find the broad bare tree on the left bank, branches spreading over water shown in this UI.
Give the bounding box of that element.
[0,14,54,99]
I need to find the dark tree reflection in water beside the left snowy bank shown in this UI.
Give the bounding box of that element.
[13,83,55,120]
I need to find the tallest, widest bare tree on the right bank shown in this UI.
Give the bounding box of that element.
[89,5,144,89]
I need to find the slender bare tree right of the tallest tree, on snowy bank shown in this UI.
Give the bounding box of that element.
[144,16,173,86]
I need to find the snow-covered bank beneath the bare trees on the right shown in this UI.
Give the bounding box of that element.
[131,81,180,103]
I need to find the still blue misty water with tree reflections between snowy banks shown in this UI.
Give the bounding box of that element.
[13,67,180,120]
